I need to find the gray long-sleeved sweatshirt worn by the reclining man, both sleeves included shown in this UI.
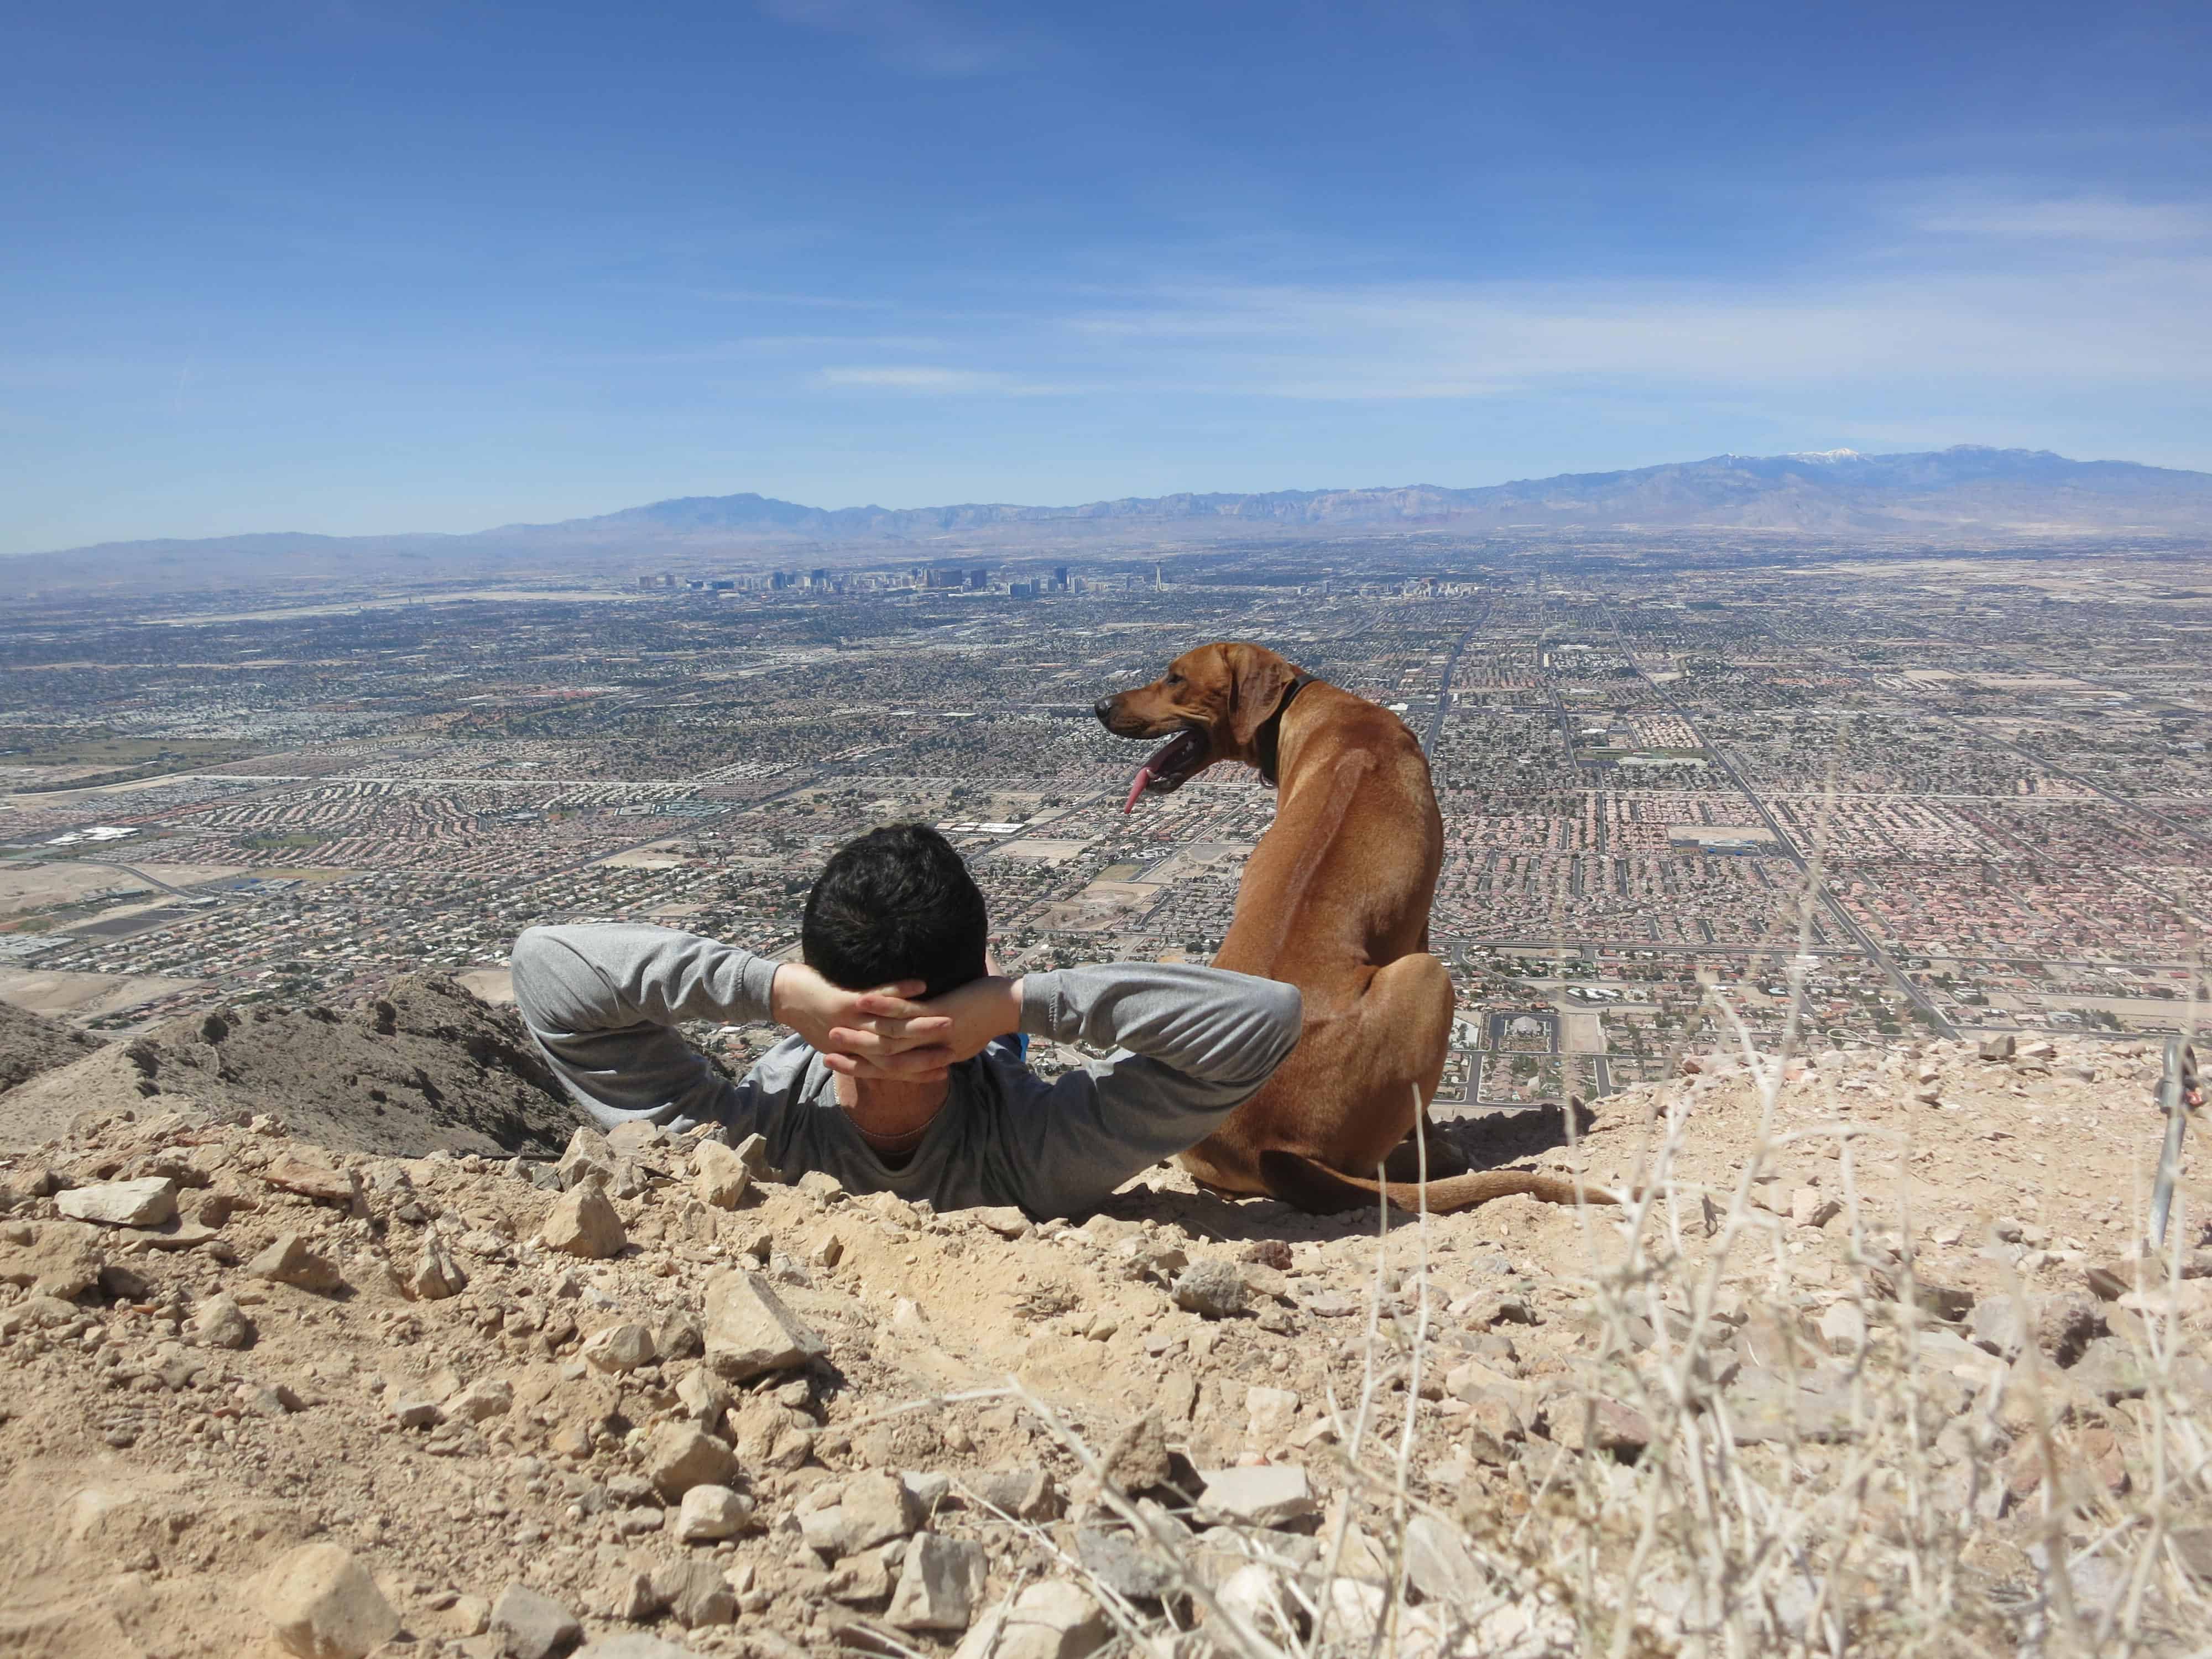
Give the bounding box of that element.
[513,922,1298,1219]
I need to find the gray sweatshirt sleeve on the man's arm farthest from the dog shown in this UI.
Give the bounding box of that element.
[511,922,776,1128]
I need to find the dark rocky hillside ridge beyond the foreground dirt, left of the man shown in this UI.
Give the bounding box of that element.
[0,973,582,1155]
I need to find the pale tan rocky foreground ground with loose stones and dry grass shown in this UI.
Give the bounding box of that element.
[0,991,2212,1659]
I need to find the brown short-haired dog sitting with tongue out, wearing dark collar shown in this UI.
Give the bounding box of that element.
[1095,644,1597,1212]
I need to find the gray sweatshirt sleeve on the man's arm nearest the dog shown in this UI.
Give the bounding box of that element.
[1009,962,1301,1217]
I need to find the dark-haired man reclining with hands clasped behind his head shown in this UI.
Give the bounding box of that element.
[513,823,1298,1221]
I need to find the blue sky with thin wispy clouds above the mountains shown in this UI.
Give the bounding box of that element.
[0,0,2212,551]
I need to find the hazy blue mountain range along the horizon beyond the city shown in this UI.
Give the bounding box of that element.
[33,445,2212,588]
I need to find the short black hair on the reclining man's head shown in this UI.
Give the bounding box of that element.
[799,823,991,995]
